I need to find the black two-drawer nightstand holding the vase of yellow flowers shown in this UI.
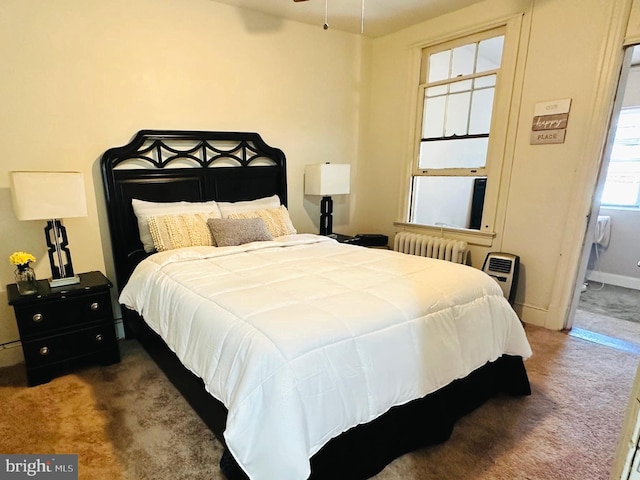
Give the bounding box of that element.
[7,272,120,386]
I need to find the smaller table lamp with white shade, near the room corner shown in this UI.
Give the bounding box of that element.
[304,163,351,235]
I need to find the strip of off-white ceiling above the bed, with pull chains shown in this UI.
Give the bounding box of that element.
[216,0,482,37]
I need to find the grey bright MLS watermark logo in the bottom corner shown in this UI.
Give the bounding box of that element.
[0,455,78,480]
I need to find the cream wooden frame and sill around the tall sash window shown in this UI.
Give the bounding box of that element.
[394,15,523,246]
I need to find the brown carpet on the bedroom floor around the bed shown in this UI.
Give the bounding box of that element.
[0,327,638,480]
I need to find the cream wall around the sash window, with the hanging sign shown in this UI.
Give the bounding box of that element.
[355,0,630,329]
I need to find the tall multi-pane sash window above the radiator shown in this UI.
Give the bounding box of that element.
[408,28,505,230]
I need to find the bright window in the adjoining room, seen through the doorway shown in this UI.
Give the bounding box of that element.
[600,107,640,208]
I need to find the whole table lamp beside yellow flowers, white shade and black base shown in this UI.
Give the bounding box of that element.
[10,172,87,287]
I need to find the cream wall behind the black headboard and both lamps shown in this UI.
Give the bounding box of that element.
[0,0,366,364]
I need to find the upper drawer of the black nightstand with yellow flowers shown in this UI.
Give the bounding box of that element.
[15,291,113,338]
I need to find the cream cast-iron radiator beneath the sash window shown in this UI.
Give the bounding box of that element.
[393,232,469,264]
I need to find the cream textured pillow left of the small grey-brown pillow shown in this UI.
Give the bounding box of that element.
[147,213,215,252]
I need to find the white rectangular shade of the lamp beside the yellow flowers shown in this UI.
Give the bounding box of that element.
[10,172,87,220]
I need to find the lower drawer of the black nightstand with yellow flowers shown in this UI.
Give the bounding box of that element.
[22,322,117,367]
